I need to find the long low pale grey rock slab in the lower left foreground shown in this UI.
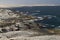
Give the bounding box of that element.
[0,31,39,38]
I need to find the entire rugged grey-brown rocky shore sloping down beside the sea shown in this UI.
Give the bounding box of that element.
[0,9,60,40]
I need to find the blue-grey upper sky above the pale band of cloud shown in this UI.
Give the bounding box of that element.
[0,0,60,4]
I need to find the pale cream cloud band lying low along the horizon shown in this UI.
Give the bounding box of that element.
[0,4,60,8]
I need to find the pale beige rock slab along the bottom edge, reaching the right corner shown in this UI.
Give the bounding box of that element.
[10,35,60,40]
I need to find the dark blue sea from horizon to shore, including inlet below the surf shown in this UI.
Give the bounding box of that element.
[10,6,60,26]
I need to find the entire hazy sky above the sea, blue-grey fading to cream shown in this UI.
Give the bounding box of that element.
[0,0,60,7]
